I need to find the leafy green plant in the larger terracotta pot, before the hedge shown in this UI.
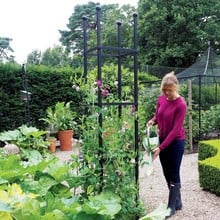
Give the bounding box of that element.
[42,102,76,151]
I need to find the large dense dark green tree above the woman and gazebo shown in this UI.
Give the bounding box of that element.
[138,0,220,68]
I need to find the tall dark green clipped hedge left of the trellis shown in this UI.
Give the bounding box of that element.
[0,63,82,131]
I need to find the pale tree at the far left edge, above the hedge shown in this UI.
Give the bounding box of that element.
[0,37,14,60]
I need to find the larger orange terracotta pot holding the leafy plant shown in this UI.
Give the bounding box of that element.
[58,130,73,151]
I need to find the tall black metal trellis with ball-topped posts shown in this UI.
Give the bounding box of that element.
[82,6,139,206]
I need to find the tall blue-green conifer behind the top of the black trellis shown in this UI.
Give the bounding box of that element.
[60,2,134,60]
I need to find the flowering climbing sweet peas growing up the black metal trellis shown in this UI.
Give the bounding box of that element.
[71,73,146,219]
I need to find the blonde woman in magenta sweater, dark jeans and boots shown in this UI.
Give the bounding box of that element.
[147,72,187,218]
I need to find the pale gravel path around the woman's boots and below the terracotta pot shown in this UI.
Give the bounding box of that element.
[55,146,220,220]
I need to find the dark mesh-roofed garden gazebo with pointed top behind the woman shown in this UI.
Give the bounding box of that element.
[176,45,220,138]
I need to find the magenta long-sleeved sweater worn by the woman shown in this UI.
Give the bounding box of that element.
[154,95,187,150]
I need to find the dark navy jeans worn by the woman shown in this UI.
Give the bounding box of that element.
[159,140,185,186]
